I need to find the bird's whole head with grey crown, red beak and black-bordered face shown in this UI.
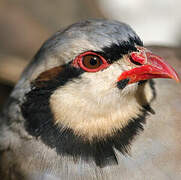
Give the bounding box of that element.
[22,20,179,166]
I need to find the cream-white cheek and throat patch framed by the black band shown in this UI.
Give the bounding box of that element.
[50,64,151,140]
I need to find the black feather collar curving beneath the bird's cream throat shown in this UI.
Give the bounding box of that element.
[22,80,153,166]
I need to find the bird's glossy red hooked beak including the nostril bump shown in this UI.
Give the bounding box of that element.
[118,47,180,84]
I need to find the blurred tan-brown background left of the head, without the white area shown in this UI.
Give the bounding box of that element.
[0,0,103,109]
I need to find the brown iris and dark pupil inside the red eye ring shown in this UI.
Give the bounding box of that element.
[82,55,102,69]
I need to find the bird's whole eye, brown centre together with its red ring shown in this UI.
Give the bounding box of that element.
[73,51,109,72]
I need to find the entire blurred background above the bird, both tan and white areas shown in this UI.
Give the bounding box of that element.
[0,0,181,109]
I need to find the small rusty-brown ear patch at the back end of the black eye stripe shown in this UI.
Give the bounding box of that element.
[33,66,63,87]
